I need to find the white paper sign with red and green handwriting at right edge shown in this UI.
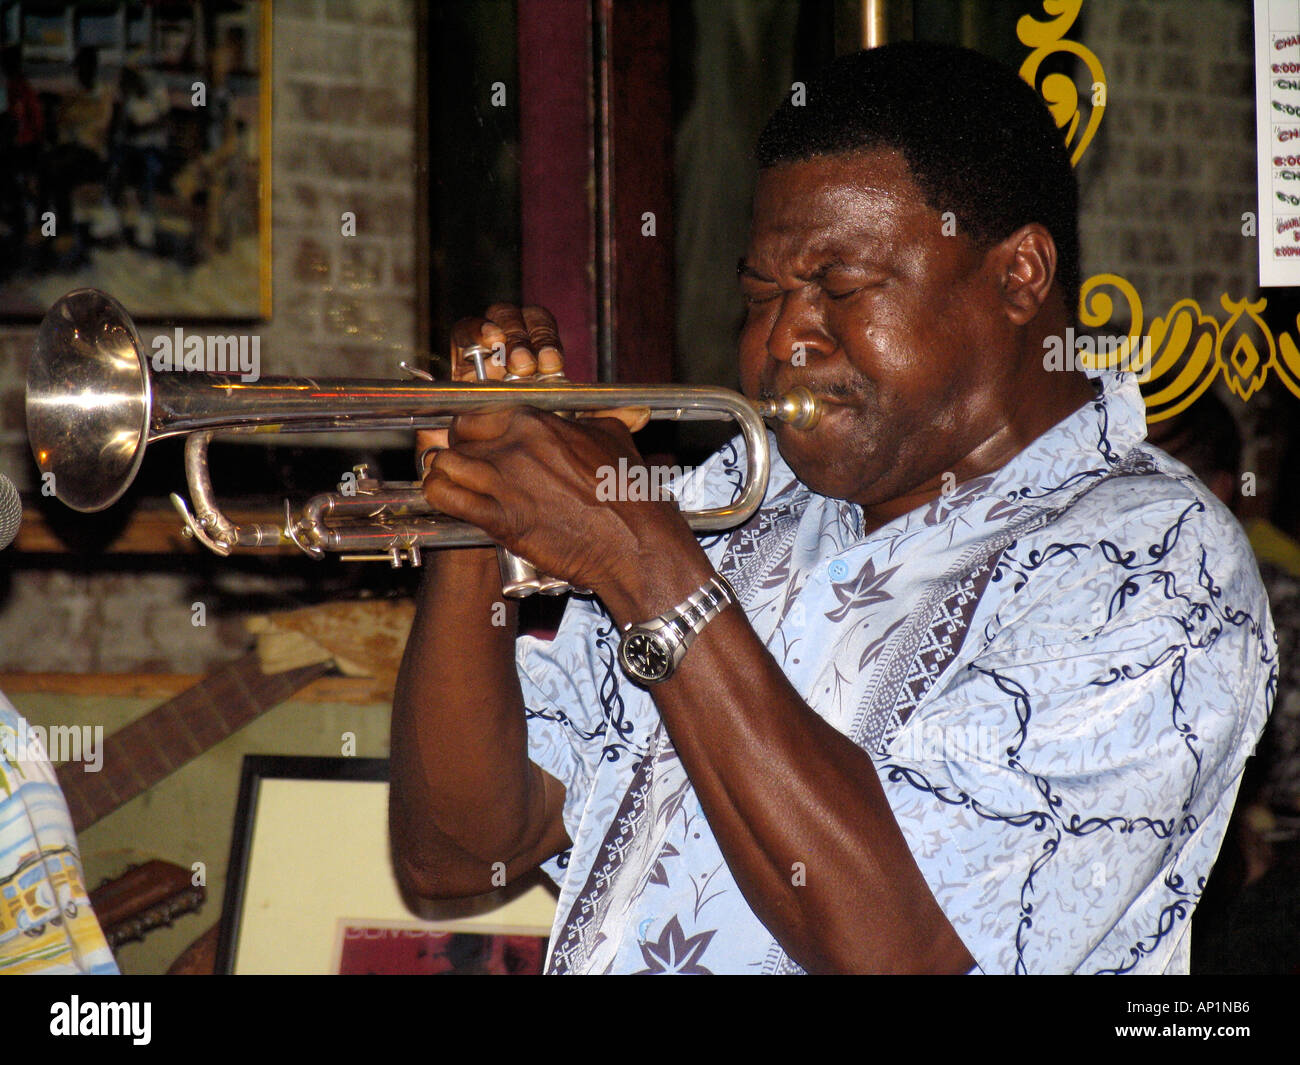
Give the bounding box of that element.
[1243,0,1300,285]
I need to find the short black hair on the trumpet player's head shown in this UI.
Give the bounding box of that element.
[755,42,1079,321]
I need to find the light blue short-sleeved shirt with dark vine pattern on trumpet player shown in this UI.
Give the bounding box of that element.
[519,375,1277,973]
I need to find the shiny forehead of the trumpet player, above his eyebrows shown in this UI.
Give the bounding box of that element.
[751,148,939,254]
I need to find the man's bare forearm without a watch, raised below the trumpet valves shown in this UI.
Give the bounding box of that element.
[390,549,566,896]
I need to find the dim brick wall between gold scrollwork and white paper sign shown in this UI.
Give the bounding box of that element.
[1069,0,1258,320]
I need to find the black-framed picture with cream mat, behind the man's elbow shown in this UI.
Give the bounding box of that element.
[216,756,555,974]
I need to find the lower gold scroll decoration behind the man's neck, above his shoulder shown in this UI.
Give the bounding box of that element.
[1078,273,1300,421]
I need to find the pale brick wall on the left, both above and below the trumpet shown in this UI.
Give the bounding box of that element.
[0,0,419,672]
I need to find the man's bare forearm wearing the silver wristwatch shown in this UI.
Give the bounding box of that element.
[595,530,974,971]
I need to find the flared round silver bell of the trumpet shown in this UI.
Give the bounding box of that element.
[27,289,151,512]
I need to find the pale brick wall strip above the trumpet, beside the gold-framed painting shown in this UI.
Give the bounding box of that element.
[271,0,416,377]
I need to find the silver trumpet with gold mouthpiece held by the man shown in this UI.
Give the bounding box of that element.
[26,289,822,596]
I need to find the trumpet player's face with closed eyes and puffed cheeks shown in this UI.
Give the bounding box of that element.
[740,150,1024,514]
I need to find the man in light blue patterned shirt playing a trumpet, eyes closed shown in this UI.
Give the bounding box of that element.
[390,46,1275,973]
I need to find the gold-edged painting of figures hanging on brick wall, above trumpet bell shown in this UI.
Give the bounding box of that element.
[0,0,272,321]
